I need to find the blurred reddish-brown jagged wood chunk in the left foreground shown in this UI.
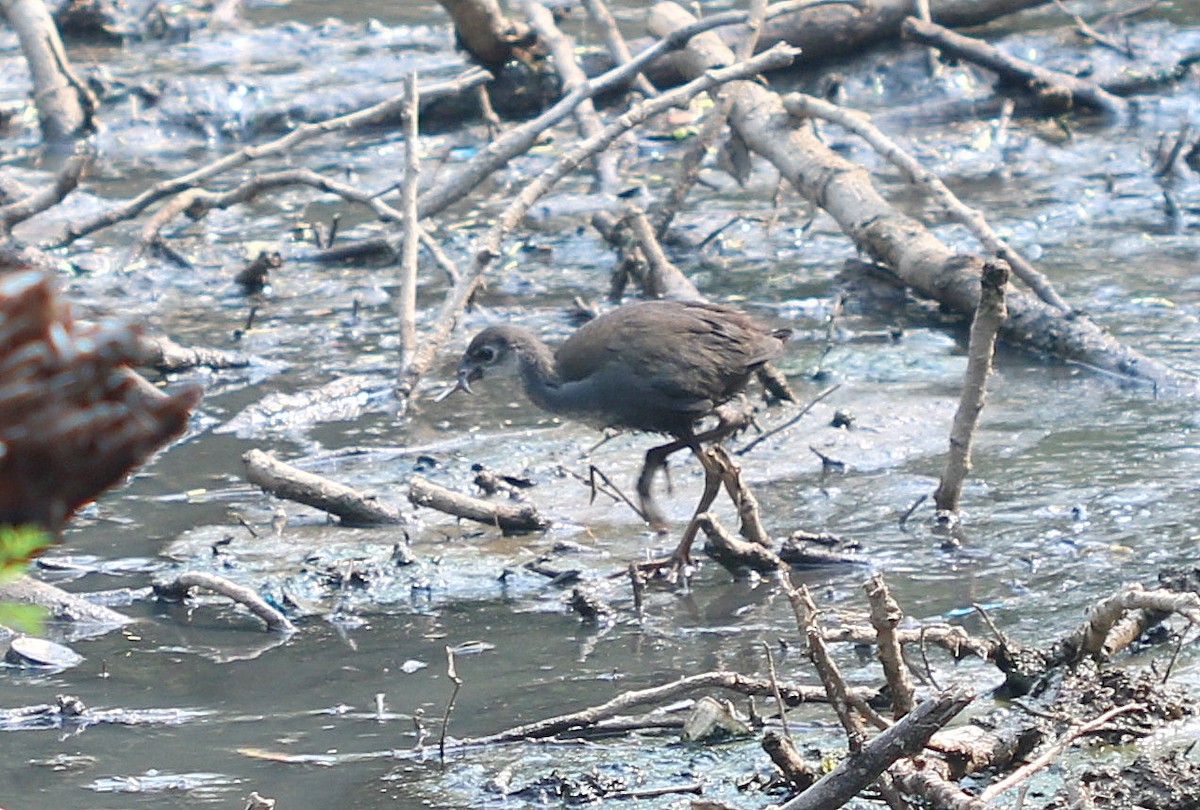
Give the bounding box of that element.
[0,270,200,534]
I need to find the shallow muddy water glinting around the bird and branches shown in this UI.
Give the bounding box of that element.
[0,2,1200,810]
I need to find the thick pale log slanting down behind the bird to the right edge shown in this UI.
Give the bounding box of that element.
[649,2,1196,392]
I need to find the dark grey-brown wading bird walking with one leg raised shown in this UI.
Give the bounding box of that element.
[458,301,791,562]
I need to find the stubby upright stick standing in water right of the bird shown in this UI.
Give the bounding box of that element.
[934,262,1008,512]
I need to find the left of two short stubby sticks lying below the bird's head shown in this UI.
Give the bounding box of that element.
[241,450,404,526]
